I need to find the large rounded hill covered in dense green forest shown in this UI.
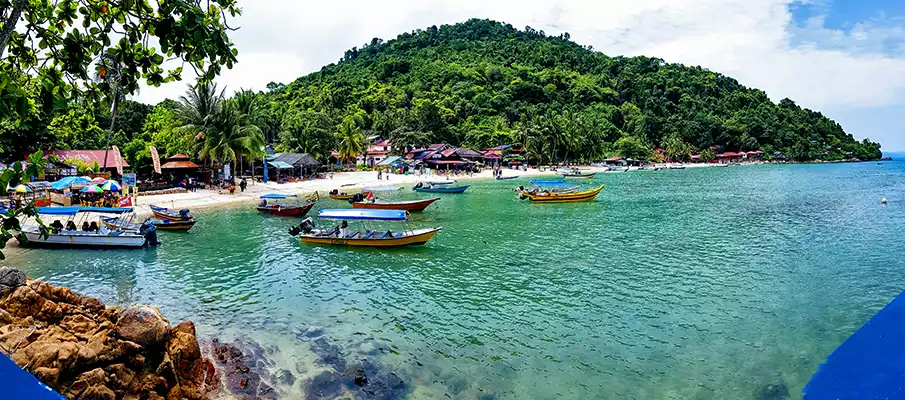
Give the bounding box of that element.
[268,19,881,162]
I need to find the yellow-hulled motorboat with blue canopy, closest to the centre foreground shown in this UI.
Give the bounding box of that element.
[289,209,440,247]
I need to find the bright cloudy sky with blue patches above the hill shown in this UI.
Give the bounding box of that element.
[136,0,905,151]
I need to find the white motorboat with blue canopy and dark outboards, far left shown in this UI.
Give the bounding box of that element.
[19,207,157,249]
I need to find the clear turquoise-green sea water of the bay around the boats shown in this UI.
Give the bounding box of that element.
[7,162,905,399]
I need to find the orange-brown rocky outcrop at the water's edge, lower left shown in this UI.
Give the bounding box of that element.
[0,268,220,400]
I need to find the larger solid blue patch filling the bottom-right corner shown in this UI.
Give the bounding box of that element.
[804,292,905,400]
